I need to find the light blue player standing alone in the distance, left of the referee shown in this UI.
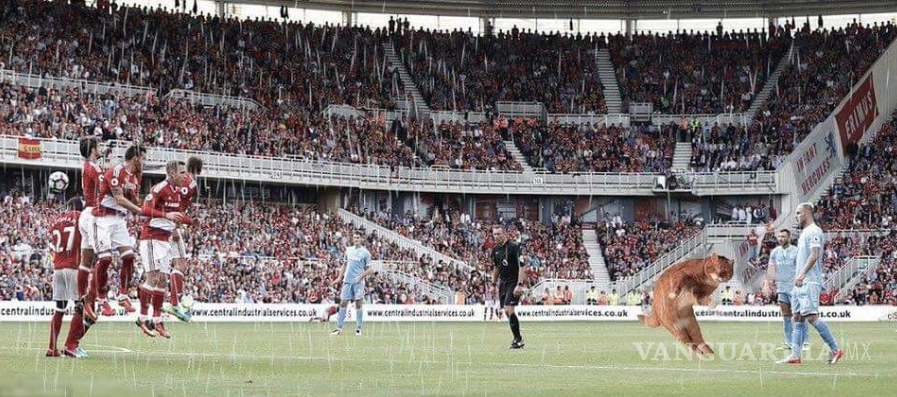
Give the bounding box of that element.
[330,232,374,336]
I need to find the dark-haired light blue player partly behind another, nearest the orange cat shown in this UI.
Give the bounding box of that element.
[763,229,797,350]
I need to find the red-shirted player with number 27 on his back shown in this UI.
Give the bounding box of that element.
[47,198,87,358]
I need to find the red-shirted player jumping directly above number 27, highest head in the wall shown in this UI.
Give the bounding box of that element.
[78,138,104,327]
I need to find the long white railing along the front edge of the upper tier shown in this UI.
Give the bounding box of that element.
[0,135,776,196]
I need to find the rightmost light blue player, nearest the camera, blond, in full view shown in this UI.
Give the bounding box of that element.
[779,203,844,365]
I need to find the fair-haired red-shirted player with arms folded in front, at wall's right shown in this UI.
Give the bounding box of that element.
[137,161,190,338]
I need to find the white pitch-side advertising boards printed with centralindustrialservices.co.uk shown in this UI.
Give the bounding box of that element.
[0,301,897,322]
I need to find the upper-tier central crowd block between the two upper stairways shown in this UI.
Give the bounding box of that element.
[397,27,607,113]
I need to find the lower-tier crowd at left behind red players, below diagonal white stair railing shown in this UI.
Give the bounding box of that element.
[0,193,456,303]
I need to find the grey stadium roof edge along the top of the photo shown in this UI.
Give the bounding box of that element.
[223,0,897,19]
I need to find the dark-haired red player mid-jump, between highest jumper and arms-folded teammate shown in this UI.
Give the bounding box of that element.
[84,145,146,322]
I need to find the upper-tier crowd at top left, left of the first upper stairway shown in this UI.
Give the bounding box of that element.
[0,0,402,114]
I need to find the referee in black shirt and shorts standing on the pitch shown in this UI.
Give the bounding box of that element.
[492,225,526,349]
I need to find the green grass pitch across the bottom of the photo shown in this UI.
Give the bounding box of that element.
[0,322,897,397]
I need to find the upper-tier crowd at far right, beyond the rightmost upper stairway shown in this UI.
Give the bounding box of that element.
[691,22,897,171]
